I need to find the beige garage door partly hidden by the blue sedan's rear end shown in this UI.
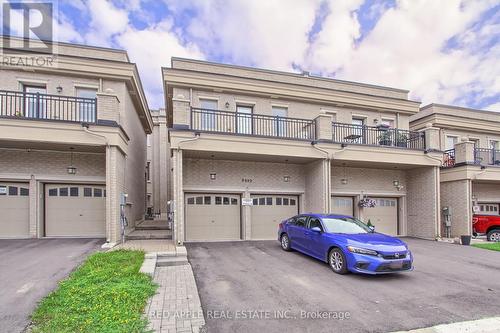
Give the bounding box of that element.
[251,195,299,239]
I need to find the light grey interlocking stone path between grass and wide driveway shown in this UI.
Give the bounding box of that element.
[145,264,205,333]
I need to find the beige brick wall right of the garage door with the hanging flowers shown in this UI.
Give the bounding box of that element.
[406,167,440,239]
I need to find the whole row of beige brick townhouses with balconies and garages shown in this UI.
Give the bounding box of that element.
[0,37,500,246]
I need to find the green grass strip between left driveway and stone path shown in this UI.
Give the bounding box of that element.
[32,250,157,333]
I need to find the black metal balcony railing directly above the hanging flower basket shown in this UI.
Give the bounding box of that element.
[332,122,425,150]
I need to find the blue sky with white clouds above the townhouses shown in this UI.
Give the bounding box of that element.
[6,0,500,112]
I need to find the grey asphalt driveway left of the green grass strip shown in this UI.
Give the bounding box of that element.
[0,239,104,332]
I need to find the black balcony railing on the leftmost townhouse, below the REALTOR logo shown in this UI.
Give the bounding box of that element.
[0,90,97,123]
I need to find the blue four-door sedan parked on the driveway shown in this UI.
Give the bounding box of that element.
[278,214,413,274]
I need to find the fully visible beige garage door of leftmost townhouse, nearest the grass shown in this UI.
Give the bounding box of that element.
[45,184,106,237]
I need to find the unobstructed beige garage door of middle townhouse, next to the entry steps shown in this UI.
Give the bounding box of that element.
[185,194,241,241]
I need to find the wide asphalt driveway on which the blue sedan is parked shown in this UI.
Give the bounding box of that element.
[187,239,500,333]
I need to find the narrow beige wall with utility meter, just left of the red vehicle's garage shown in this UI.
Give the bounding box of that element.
[440,180,472,237]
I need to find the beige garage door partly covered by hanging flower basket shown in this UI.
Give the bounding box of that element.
[363,198,398,235]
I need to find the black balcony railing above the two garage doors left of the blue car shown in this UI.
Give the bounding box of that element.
[191,108,316,140]
